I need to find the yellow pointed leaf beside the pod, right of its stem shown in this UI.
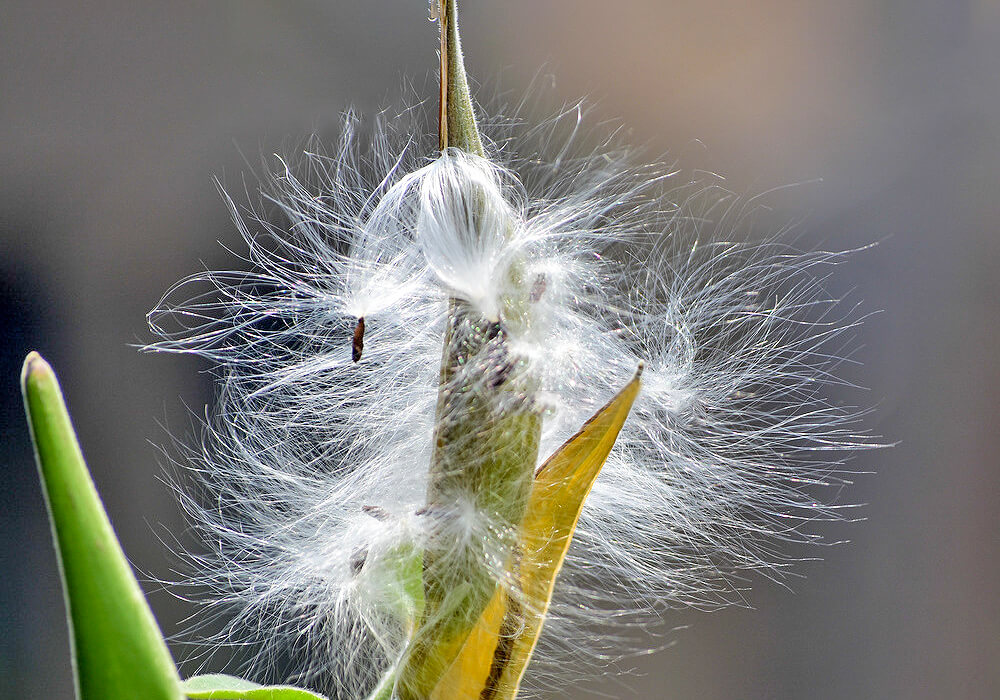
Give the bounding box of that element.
[431,365,642,700]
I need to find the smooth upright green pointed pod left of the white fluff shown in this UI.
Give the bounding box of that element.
[21,352,183,700]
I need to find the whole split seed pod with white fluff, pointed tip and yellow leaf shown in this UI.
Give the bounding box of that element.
[150,2,868,700]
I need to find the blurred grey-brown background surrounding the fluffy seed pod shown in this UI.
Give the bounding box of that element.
[0,0,1000,700]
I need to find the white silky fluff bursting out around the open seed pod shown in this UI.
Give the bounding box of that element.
[148,101,870,698]
